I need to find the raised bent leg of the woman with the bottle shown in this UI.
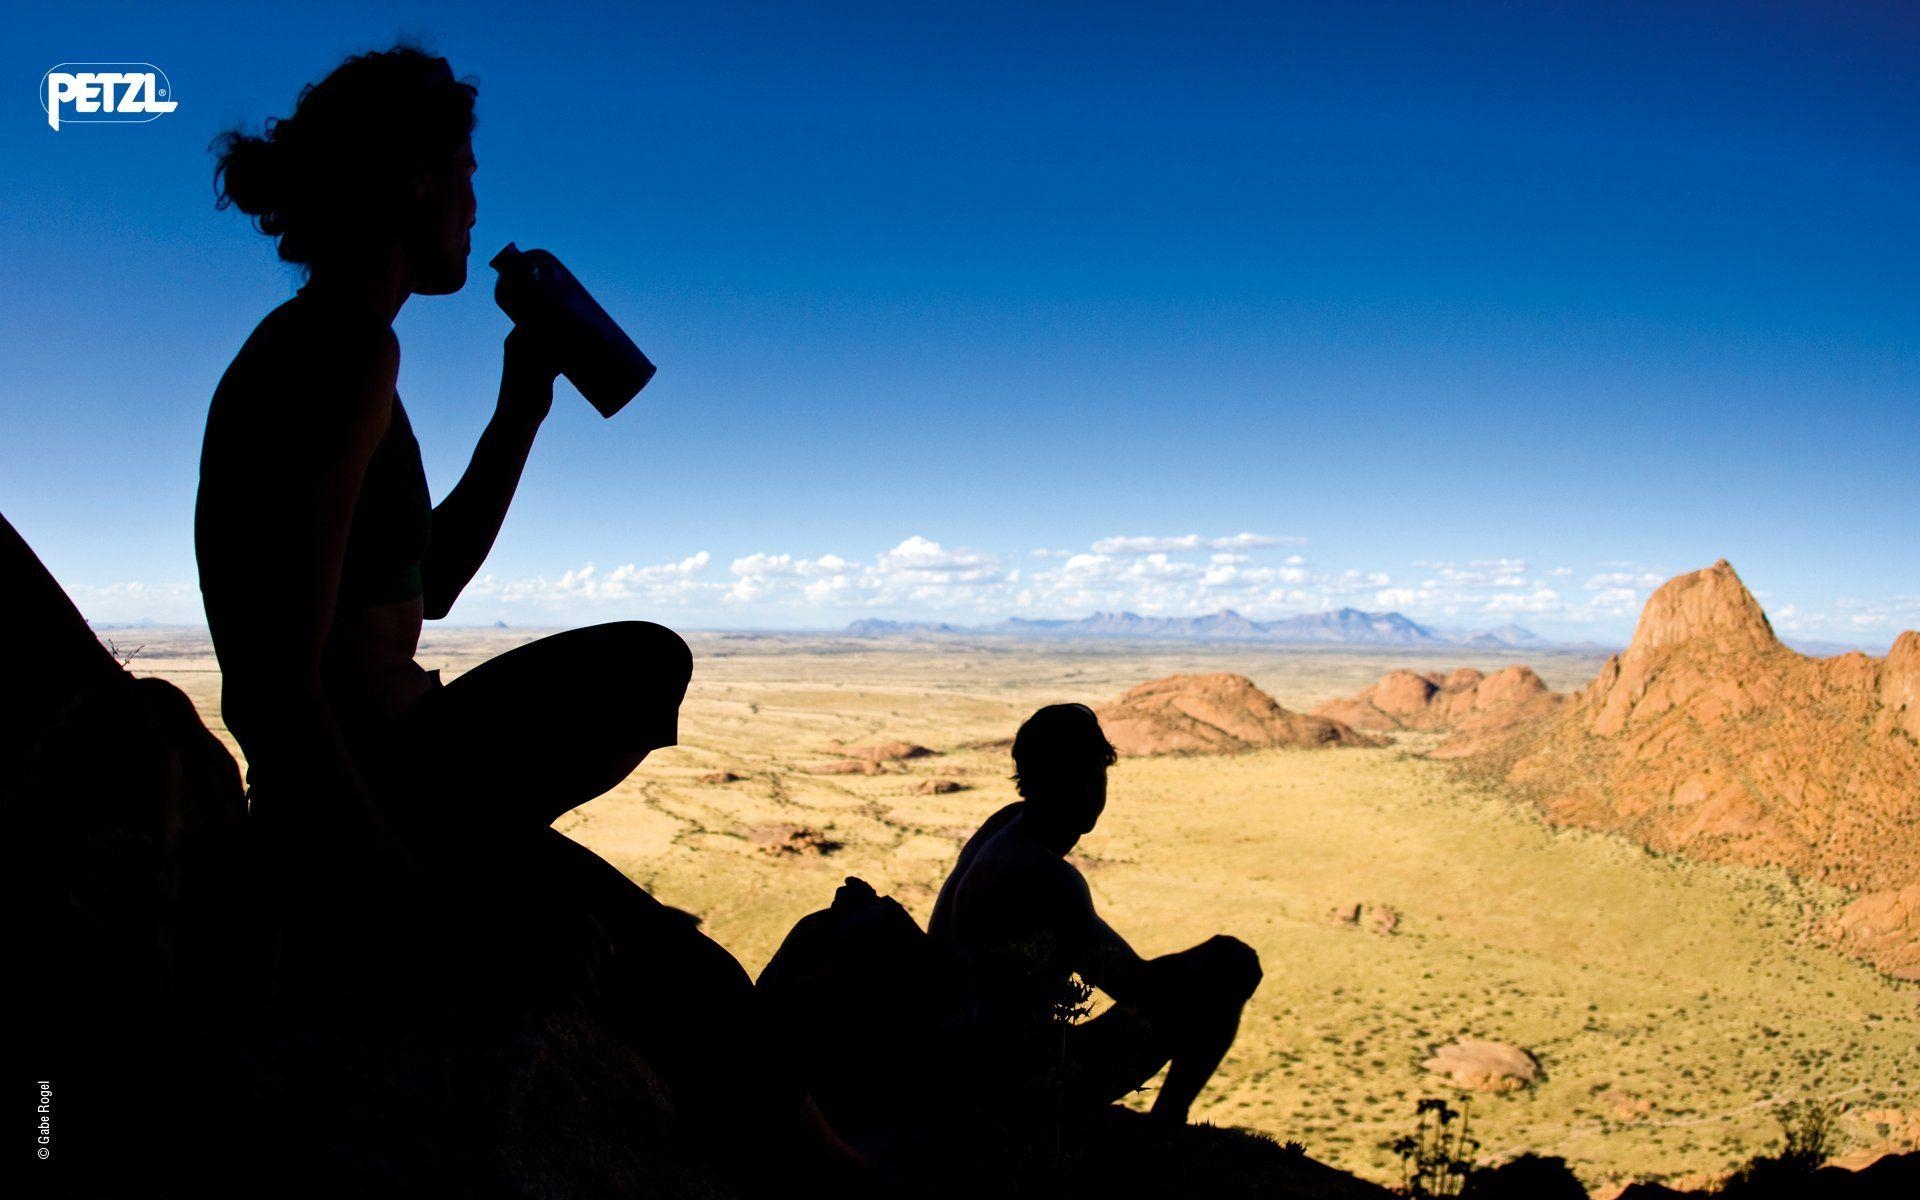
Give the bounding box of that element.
[390,620,693,831]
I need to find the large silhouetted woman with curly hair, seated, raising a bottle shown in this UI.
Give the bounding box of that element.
[196,48,691,890]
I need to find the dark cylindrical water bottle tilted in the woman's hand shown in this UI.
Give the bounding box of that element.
[488,242,653,417]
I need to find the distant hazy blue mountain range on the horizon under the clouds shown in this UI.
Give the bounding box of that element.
[847,609,1553,649]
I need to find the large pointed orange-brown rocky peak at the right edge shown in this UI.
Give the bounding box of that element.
[1444,561,1920,977]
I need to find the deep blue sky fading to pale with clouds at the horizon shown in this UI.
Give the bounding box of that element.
[0,2,1920,645]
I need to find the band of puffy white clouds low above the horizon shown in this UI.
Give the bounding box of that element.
[432,534,1889,636]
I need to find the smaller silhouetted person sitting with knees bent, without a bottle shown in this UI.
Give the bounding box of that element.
[929,705,1260,1123]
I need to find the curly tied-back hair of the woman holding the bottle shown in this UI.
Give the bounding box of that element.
[207,44,480,271]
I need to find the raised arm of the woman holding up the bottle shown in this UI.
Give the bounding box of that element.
[420,328,559,620]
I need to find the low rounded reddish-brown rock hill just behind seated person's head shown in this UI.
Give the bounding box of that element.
[1094,674,1384,756]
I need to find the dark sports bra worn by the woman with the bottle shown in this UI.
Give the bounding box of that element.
[338,392,434,609]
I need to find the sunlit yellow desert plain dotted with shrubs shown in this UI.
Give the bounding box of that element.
[116,628,1920,1190]
